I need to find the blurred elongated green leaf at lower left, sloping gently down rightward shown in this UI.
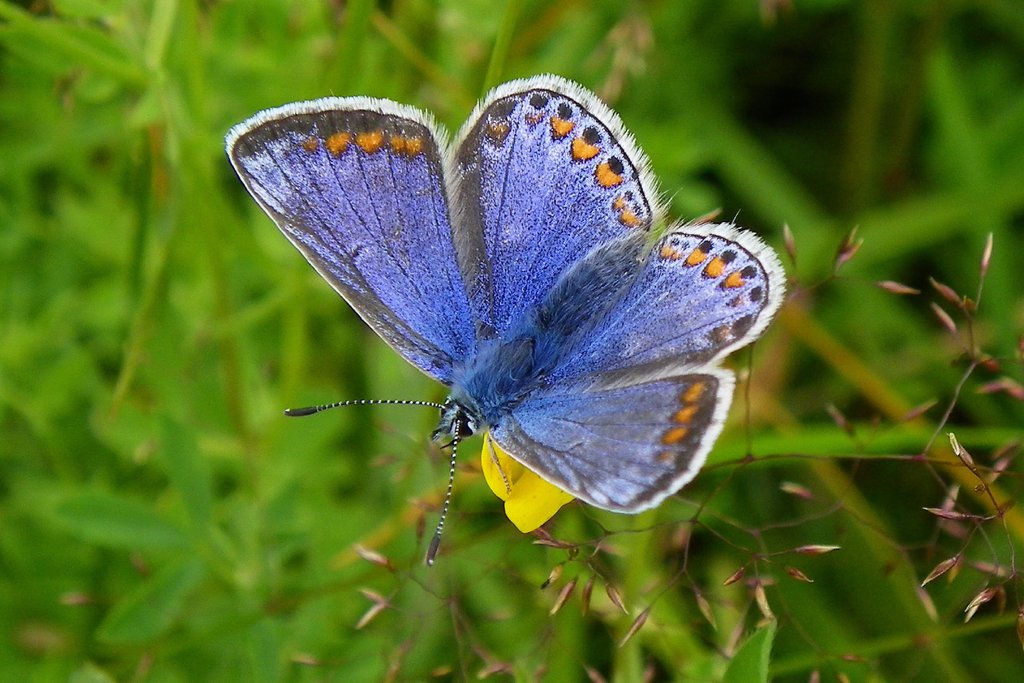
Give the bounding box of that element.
[56,492,188,550]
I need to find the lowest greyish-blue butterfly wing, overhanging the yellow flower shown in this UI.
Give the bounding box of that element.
[492,369,734,513]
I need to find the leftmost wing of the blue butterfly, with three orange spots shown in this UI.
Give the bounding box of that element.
[226,97,474,384]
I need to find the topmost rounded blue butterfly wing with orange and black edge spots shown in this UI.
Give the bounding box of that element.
[455,76,659,339]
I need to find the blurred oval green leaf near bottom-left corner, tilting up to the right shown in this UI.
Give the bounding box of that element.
[96,558,206,644]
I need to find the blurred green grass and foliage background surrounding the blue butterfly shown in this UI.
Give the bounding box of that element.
[0,0,1024,682]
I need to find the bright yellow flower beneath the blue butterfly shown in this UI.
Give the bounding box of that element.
[480,432,572,533]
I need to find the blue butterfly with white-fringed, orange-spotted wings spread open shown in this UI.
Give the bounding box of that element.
[226,76,784,557]
